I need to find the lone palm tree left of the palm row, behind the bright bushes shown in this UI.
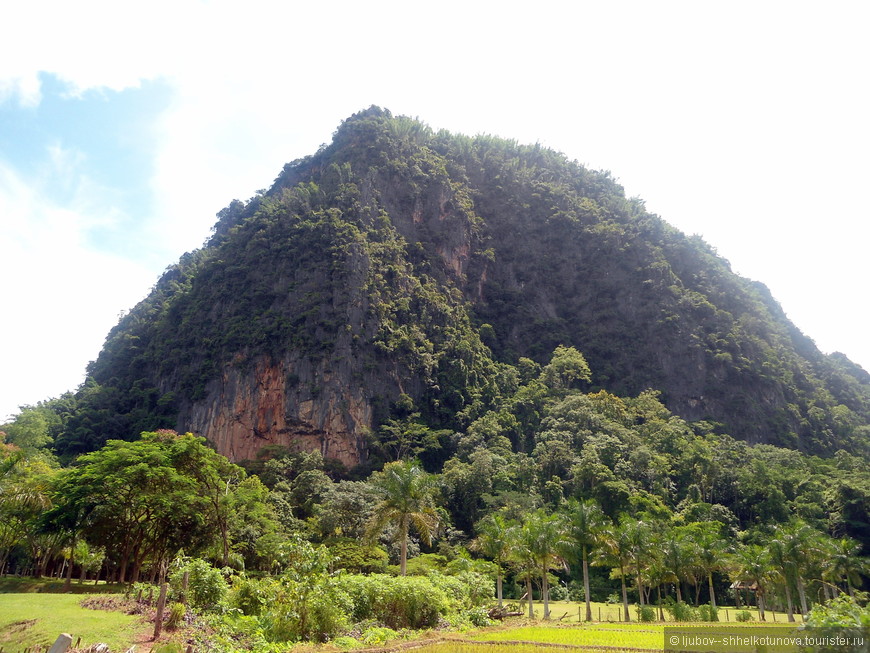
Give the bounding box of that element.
[367,461,439,576]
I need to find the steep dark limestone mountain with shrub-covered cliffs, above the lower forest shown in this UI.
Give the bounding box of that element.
[61,109,870,465]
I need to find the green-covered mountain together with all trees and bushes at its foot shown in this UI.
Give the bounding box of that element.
[0,108,870,650]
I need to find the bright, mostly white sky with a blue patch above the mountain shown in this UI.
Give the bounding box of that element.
[0,0,870,423]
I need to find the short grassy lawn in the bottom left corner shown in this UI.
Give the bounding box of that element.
[0,578,149,651]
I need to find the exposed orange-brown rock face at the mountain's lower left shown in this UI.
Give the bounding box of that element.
[179,358,372,467]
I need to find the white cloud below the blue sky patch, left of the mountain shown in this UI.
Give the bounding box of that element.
[0,155,154,421]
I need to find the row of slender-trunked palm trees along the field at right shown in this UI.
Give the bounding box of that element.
[474,500,870,621]
